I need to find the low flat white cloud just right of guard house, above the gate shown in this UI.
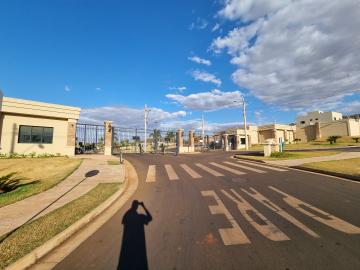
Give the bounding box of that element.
[79,106,186,128]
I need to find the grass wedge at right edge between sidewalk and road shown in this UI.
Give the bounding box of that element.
[302,158,360,177]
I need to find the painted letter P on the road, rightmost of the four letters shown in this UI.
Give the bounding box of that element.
[269,186,360,234]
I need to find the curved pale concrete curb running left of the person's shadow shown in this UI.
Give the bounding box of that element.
[5,162,129,270]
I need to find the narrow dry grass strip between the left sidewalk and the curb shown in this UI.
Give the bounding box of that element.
[0,183,120,269]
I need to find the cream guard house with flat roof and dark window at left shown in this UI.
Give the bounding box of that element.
[0,92,80,156]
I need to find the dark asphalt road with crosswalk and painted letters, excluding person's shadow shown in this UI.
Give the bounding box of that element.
[55,152,360,270]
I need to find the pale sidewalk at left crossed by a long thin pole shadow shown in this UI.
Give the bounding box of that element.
[0,155,125,236]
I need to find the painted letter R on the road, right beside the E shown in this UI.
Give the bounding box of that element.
[221,189,290,241]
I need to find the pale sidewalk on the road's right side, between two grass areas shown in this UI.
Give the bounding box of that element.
[264,152,360,167]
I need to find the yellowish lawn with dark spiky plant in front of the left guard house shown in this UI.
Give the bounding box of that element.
[0,157,82,207]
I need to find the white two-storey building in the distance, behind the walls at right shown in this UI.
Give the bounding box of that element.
[296,111,342,127]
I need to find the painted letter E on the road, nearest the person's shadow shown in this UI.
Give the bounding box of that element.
[201,190,251,246]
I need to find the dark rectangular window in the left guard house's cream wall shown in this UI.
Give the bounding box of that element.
[18,126,54,143]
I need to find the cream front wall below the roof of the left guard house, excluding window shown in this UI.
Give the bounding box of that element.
[0,114,75,156]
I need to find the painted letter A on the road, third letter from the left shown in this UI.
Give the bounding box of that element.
[241,188,320,238]
